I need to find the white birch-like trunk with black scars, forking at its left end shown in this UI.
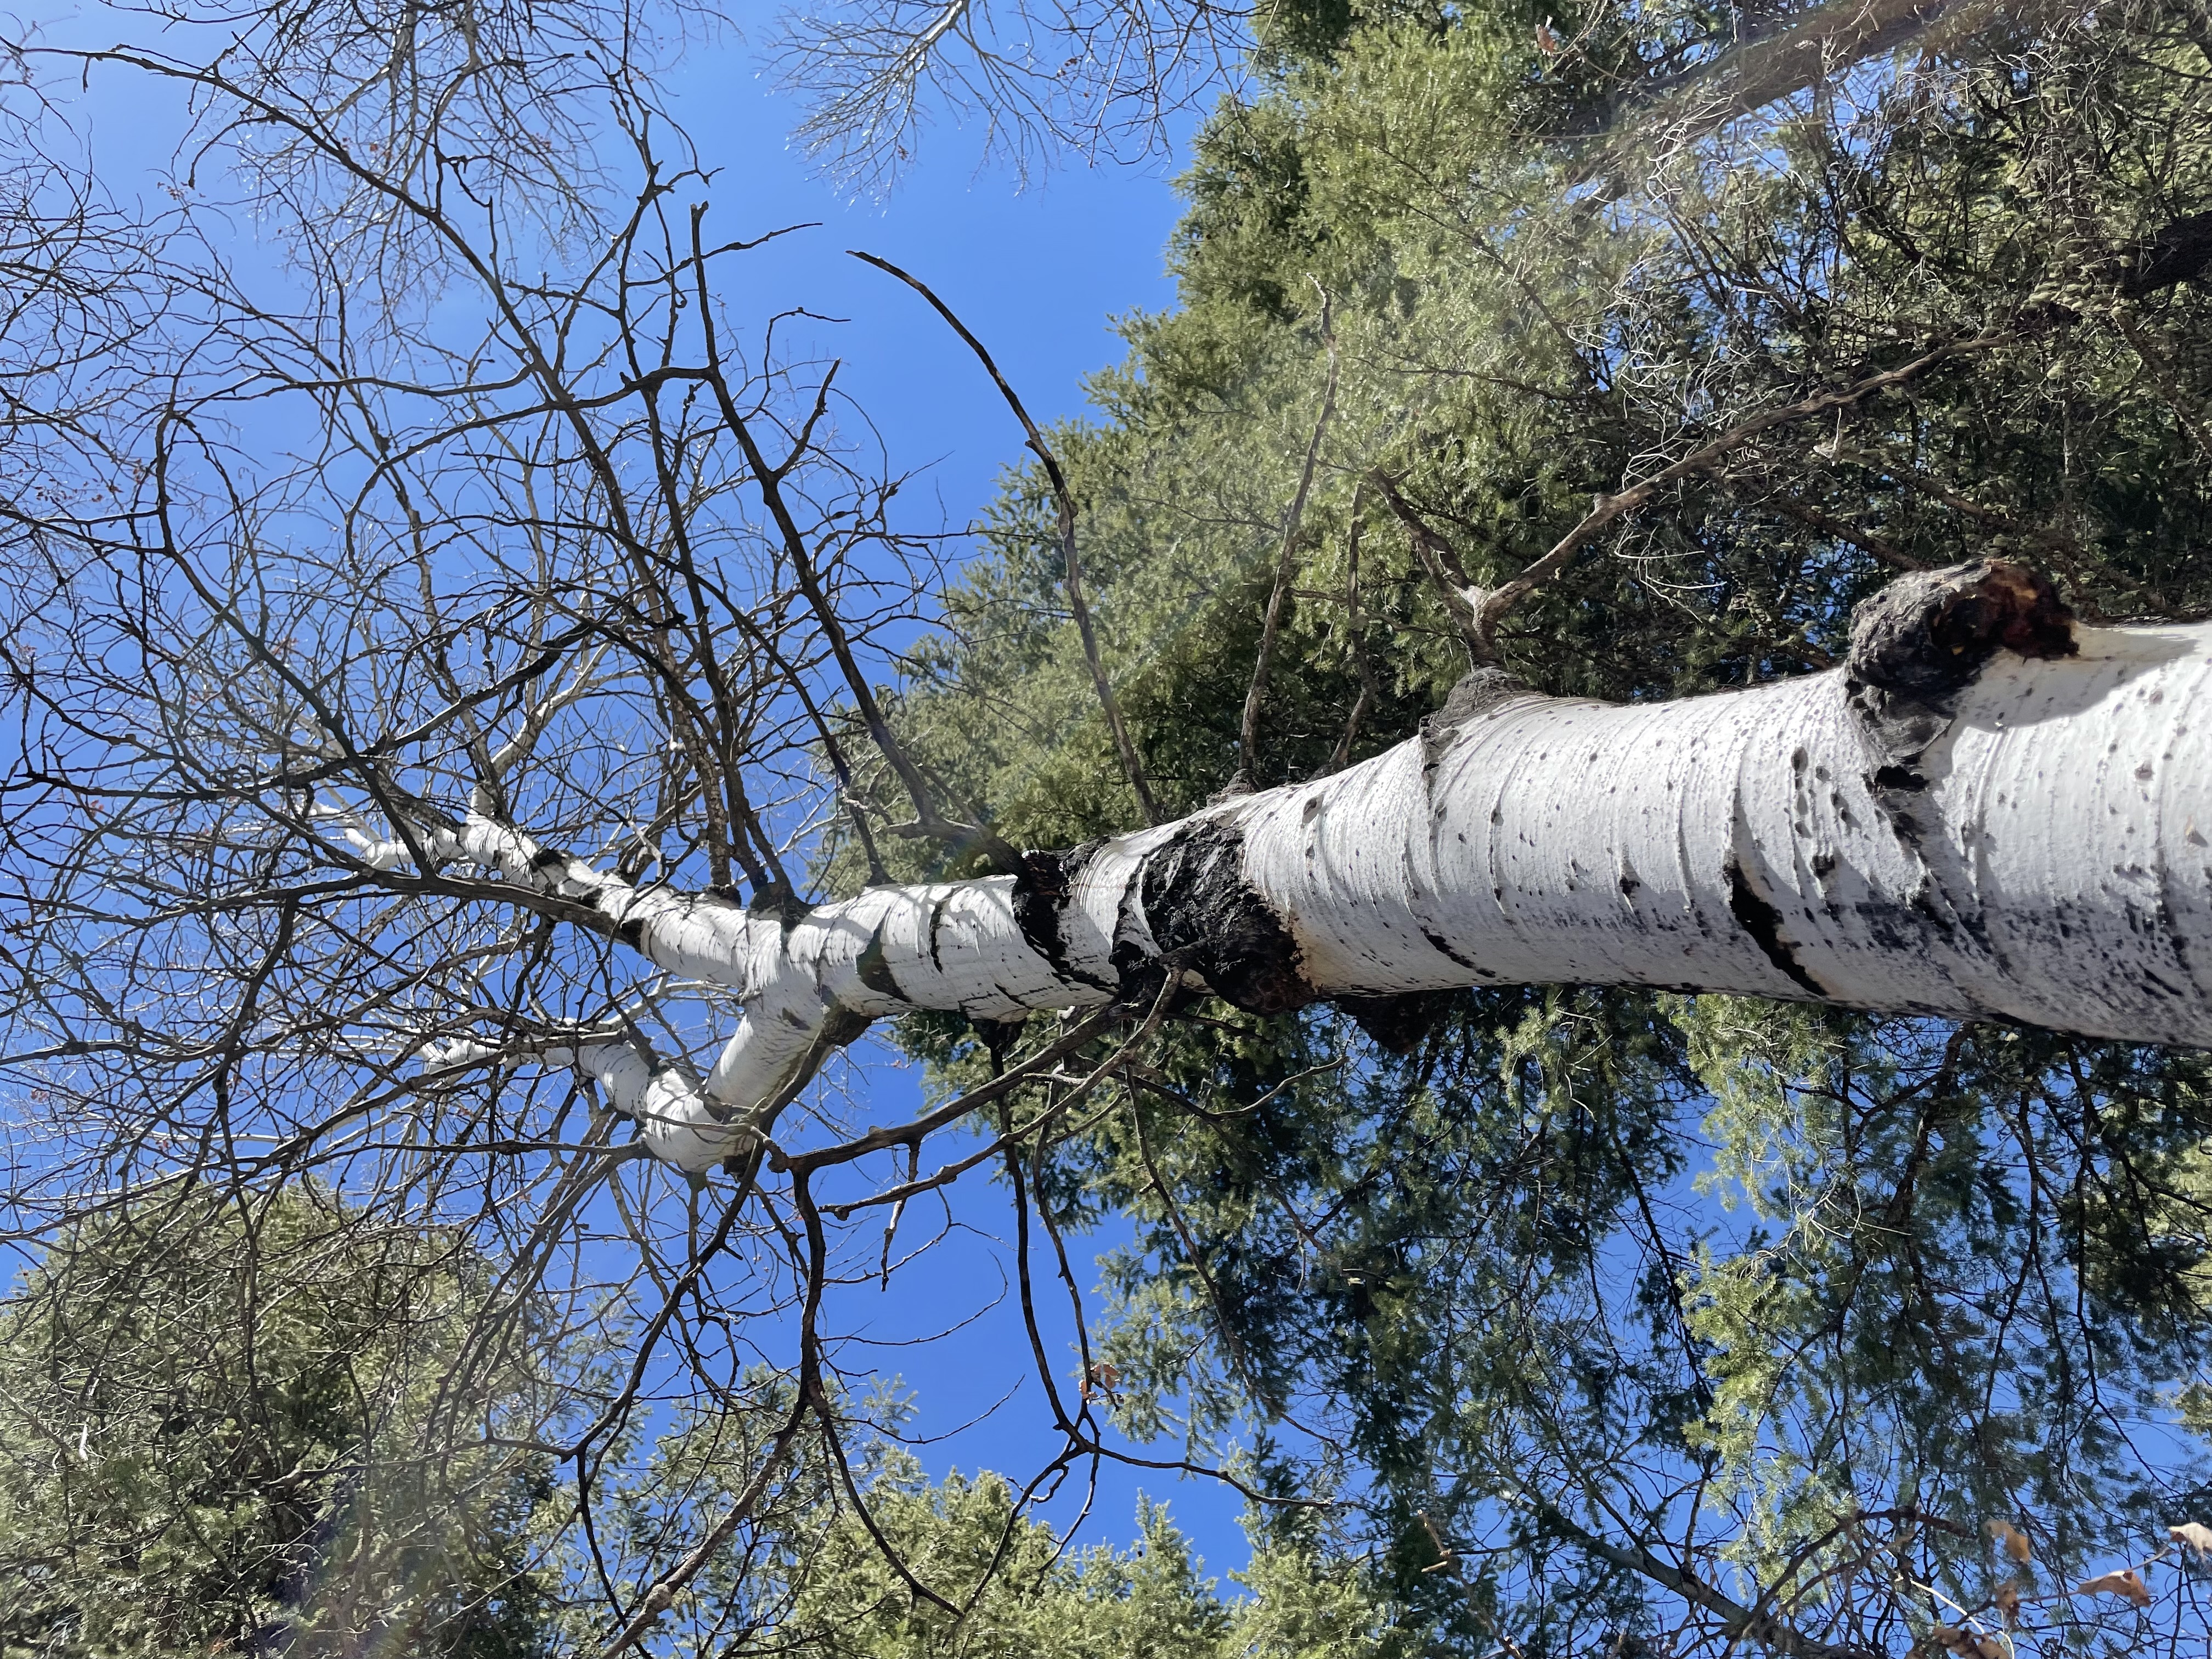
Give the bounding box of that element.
[385,564,2212,1170]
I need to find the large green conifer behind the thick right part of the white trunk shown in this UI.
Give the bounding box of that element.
[871,4,2212,1655]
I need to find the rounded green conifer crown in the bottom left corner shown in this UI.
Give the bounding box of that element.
[0,1190,557,1659]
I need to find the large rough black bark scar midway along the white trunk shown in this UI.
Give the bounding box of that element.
[1142,819,1314,1013]
